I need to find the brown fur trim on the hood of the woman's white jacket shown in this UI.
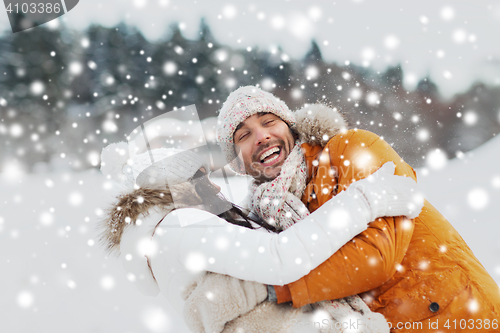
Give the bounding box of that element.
[98,183,202,254]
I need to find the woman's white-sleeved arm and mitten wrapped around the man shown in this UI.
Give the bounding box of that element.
[154,161,421,285]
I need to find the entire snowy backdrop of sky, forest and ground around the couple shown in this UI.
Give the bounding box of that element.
[0,0,500,333]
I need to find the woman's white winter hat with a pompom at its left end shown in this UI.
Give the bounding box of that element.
[101,142,210,188]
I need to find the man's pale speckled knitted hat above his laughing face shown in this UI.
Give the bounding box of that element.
[217,86,295,174]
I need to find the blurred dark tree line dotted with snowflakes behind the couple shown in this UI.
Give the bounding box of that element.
[0,20,500,172]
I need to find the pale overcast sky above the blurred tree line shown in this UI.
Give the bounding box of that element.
[0,0,500,96]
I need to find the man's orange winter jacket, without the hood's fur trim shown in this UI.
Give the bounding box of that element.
[275,130,500,332]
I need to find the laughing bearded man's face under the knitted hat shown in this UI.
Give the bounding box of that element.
[233,113,295,182]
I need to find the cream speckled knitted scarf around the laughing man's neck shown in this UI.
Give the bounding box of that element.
[250,141,309,230]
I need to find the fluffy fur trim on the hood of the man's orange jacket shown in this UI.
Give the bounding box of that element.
[293,103,347,146]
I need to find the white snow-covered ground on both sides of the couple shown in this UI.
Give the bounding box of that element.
[0,137,500,333]
